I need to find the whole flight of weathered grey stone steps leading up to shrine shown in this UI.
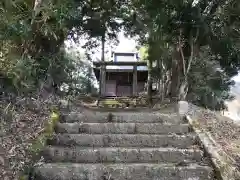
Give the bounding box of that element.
[31,112,214,180]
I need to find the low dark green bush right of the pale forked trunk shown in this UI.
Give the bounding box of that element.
[187,48,233,110]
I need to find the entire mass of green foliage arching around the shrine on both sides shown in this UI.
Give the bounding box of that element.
[0,0,240,108]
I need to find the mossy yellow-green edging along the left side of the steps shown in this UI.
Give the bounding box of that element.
[19,107,60,180]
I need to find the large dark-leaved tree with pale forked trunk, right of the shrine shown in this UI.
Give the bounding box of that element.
[123,0,239,109]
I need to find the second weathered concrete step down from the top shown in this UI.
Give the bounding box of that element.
[55,123,190,134]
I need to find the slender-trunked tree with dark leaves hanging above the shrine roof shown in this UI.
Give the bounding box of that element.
[80,0,127,61]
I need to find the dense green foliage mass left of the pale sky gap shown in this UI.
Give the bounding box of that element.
[0,0,89,95]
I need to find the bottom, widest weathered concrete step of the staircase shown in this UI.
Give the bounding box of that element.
[34,163,213,180]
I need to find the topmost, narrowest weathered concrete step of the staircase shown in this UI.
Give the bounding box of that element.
[61,112,185,124]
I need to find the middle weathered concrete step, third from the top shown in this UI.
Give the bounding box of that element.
[48,134,197,148]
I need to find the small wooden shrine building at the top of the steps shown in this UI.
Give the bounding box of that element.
[93,52,148,97]
